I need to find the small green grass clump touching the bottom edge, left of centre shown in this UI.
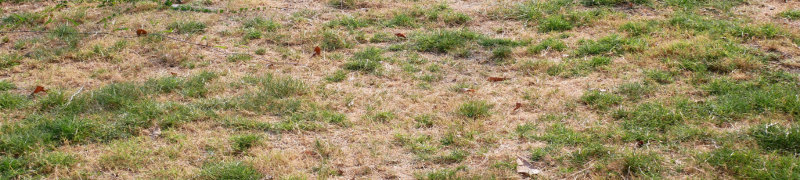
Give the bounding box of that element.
[198,161,264,180]
